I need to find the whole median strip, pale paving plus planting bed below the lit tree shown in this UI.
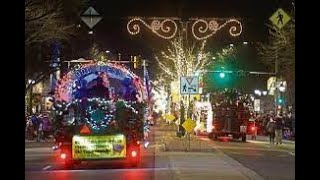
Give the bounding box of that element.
[155,125,263,180]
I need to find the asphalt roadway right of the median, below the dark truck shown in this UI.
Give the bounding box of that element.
[201,138,295,180]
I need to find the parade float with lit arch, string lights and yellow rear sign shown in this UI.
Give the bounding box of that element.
[53,61,149,168]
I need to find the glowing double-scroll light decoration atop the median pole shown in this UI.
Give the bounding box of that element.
[127,17,242,40]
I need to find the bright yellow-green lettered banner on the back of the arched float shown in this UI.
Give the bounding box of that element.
[72,135,126,159]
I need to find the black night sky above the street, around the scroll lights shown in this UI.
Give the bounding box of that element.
[67,0,292,93]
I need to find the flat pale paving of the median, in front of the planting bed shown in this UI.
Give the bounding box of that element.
[155,152,263,180]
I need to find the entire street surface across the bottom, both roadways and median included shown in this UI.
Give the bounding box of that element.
[25,127,295,180]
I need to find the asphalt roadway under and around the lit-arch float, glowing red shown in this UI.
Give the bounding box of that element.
[25,126,175,180]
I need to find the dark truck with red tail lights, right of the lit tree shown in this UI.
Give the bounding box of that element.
[208,89,252,142]
